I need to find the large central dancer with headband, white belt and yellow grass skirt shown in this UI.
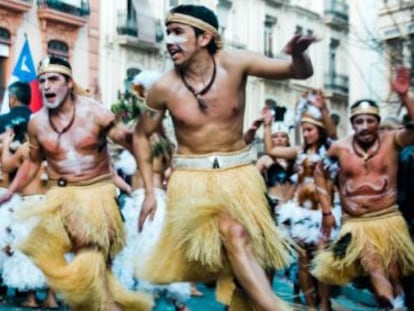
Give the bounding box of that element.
[134,5,315,311]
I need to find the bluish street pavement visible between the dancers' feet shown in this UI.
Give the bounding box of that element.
[0,275,380,311]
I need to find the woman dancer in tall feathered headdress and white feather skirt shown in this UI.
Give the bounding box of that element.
[265,91,340,310]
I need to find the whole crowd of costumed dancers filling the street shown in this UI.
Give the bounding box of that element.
[0,5,414,311]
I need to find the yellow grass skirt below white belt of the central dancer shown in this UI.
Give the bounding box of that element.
[137,165,292,310]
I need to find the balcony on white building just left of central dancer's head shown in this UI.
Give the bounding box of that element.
[116,11,164,51]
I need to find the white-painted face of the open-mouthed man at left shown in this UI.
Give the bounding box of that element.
[39,72,73,109]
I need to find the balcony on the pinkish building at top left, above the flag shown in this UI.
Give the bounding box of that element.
[37,0,90,28]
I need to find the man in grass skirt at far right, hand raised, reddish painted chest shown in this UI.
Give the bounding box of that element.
[312,67,414,310]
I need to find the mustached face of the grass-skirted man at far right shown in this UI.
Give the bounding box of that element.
[352,114,379,144]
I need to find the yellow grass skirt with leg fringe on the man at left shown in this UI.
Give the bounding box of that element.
[16,180,152,311]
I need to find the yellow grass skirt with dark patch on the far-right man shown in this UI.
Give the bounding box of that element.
[311,207,414,285]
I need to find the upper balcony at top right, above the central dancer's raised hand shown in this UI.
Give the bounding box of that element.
[324,0,349,31]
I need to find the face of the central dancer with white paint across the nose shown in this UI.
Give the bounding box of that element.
[165,23,196,65]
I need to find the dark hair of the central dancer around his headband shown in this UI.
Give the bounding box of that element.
[170,4,219,54]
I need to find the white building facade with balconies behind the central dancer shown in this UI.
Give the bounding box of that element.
[100,0,349,139]
